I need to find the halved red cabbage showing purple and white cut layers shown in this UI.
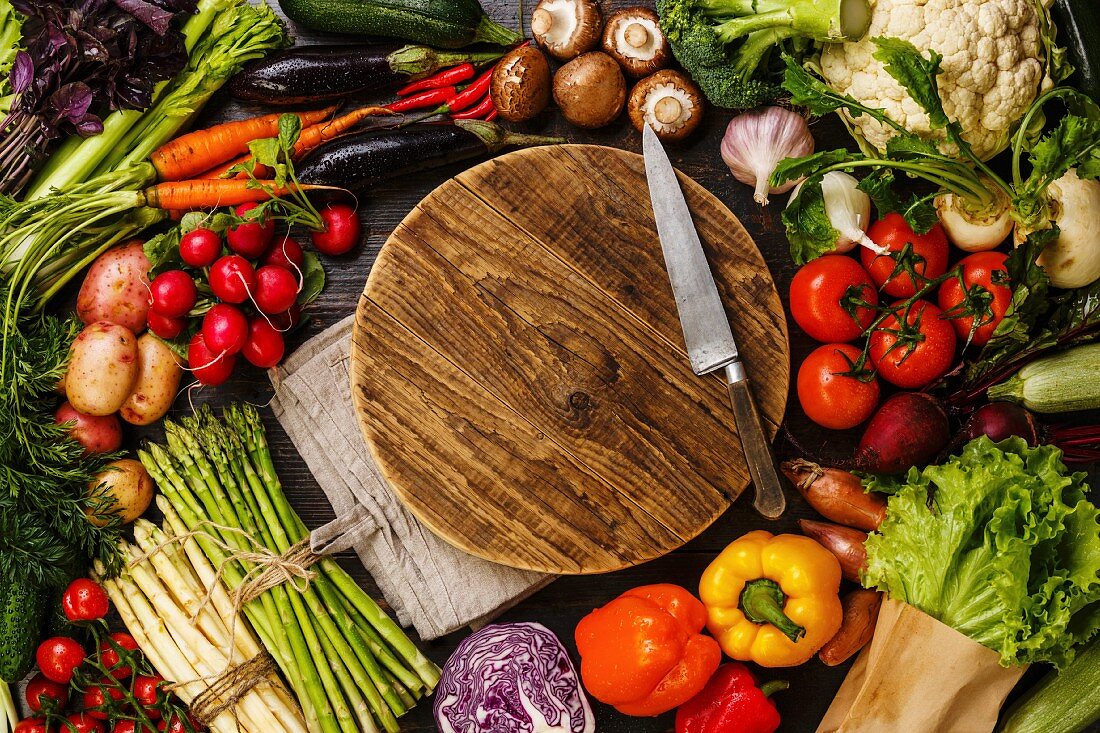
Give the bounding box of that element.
[435,623,596,733]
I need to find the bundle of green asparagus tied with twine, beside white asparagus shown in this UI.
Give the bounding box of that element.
[139,406,439,733]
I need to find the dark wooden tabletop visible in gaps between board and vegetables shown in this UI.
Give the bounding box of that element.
[133,0,1060,733]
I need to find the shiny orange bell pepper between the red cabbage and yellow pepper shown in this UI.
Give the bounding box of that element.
[576,583,722,716]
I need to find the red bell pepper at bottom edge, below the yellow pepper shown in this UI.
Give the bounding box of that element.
[675,661,787,733]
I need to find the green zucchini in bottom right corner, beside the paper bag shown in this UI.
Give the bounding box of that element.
[998,638,1100,733]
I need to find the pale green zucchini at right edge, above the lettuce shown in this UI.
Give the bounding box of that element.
[988,343,1100,413]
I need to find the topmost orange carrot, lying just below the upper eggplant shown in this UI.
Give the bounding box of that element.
[150,107,336,180]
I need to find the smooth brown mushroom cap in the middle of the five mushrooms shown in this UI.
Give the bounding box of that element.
[553,51,626,129]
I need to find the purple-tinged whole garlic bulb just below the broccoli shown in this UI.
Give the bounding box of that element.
[722,107,814,206]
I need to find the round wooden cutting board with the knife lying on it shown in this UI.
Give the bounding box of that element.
[351,145,790,572]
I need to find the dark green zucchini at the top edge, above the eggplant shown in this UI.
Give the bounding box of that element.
[272,0,523,48]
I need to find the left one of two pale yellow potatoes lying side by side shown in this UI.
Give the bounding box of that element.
[65,320,138,415]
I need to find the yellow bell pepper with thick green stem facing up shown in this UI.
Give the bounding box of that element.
[699,529,843,667]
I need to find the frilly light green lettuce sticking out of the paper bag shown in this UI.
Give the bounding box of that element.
[862,436,1100,667]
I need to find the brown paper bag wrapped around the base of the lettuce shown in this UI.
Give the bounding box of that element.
[817,599,1026,733]
